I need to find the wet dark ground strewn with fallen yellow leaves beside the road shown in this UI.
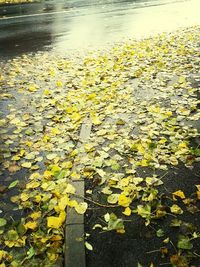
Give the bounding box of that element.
[0,27,200,267]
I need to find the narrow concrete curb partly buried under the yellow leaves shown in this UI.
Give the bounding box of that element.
[64,118,92,267]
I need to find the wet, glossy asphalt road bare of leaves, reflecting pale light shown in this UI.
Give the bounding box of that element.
[0,0,200,59]
